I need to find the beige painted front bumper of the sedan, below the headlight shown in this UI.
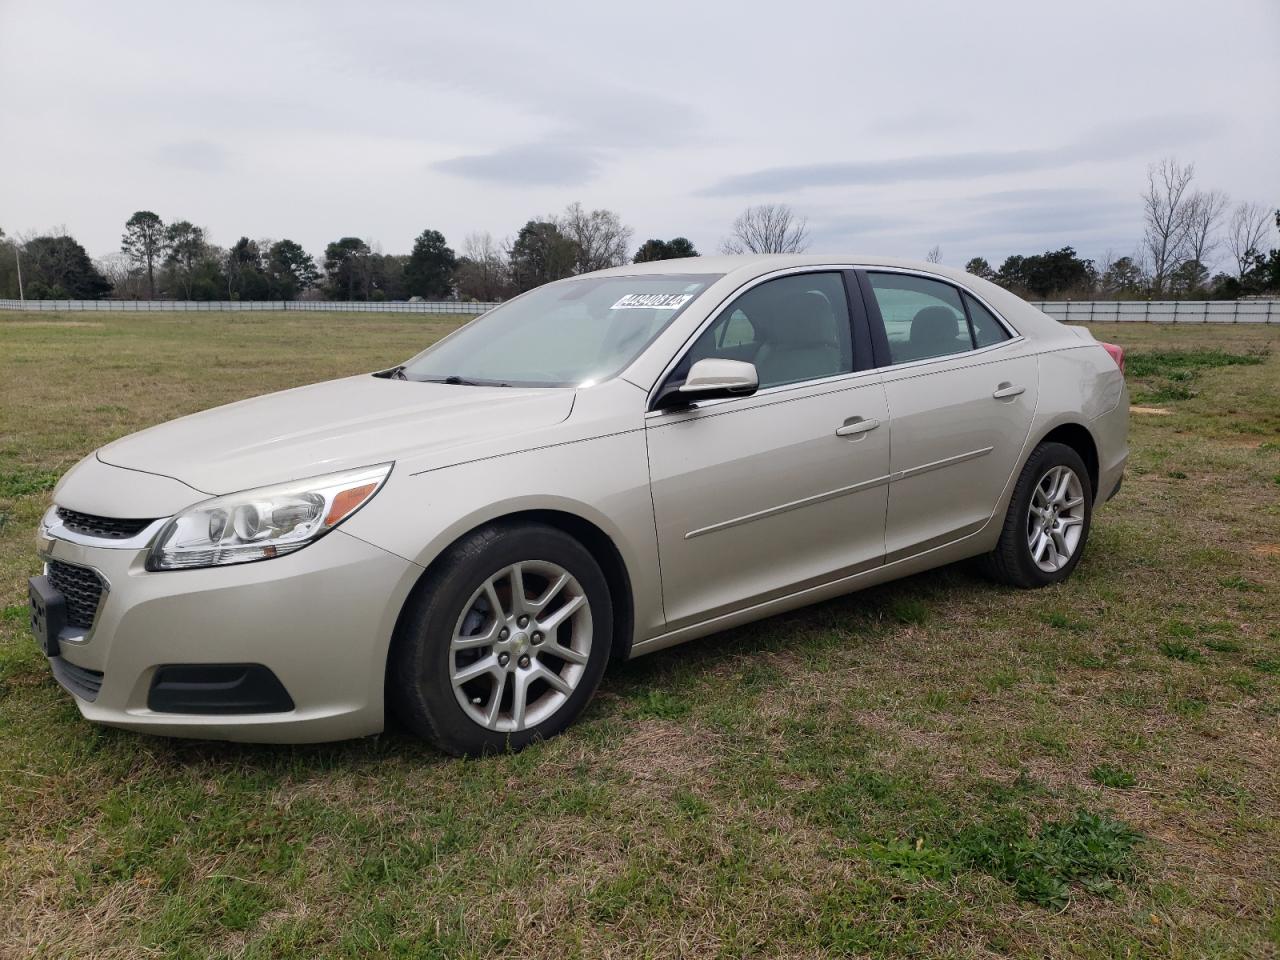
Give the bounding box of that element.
[40,530,421,742]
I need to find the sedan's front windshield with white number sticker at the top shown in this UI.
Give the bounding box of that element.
[397,274,718,387]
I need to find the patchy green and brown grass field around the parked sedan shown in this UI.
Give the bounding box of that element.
[0,314,1280,959]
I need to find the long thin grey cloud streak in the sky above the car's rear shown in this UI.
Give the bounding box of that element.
[699,115,1219,197]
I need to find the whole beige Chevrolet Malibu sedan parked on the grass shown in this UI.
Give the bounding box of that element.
[29,256,1128,754]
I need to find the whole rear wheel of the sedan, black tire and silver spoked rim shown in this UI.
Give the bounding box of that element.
[982,443,1093,589]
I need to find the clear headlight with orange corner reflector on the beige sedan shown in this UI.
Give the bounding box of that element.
[147,463,392,570]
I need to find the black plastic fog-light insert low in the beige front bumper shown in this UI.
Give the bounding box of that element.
[147,663,293,714]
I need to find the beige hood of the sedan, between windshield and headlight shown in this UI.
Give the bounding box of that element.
[97,375,573,494]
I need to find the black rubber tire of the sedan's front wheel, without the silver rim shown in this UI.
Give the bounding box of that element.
[390,524,613,755]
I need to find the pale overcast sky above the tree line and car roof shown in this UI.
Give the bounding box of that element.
[0,0,1280,266]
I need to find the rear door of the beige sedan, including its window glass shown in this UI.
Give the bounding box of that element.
[860,270,1038,562]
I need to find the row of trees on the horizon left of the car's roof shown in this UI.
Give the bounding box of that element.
[0,202,698,301]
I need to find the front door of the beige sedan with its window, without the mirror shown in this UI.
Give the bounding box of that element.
[646,271,890,628]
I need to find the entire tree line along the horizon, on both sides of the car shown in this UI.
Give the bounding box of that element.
[0,159,1280,301]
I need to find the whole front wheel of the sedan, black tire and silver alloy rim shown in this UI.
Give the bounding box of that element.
[387,524,613,756]
